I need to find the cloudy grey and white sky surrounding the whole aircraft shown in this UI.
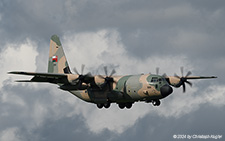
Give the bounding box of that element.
[0,0,225,141]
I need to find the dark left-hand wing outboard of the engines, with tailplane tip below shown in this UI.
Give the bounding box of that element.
[8,71,69,84]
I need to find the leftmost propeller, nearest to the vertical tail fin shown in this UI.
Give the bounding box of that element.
[73,64,91,89]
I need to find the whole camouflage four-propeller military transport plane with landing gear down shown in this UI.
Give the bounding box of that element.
[9,35,216,109]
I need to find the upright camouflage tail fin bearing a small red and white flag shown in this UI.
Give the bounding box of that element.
[48,35,71,73]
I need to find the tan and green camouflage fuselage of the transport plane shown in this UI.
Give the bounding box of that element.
[70,74,172,103]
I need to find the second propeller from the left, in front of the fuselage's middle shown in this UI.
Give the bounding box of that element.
[99,66,116,91]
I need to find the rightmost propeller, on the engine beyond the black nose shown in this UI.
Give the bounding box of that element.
[174,67,192,92]
